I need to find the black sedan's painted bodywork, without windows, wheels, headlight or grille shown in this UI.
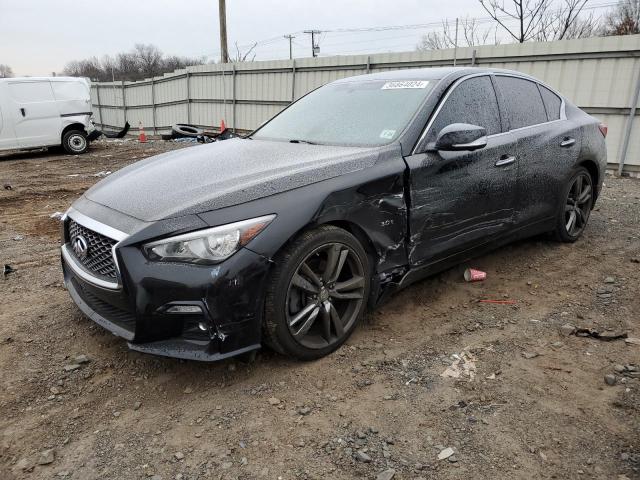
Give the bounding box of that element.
[63,68,606,360]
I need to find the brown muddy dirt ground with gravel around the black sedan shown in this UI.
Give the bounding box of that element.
[0,141,640,480]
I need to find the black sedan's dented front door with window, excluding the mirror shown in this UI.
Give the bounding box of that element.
[406,75,517,266]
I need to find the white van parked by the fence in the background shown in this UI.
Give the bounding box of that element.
[0,77,97,154]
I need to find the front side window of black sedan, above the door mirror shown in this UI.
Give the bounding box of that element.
[427,76,502,142]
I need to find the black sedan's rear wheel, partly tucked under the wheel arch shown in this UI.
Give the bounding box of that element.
[554,167,594,243]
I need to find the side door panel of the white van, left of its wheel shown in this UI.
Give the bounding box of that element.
[7,80,61,147]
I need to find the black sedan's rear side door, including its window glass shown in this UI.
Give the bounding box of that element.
[494,74,580,225]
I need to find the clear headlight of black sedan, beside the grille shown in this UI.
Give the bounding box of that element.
[142,215,276,264]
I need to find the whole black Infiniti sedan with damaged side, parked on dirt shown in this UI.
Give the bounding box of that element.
[62,68,606,360]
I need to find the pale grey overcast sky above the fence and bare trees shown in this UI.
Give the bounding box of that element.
[0,0,496,75]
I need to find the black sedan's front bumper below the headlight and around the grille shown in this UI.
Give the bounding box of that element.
[62,234,270,361]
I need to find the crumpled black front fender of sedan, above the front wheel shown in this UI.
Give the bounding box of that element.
[198,146,407,273]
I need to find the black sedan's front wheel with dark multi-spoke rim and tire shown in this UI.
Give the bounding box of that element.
[263,225,370,360]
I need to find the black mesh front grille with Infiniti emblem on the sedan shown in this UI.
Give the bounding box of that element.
[68,220,117,280]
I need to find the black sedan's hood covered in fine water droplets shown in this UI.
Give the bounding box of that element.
[85,139,378,222]
